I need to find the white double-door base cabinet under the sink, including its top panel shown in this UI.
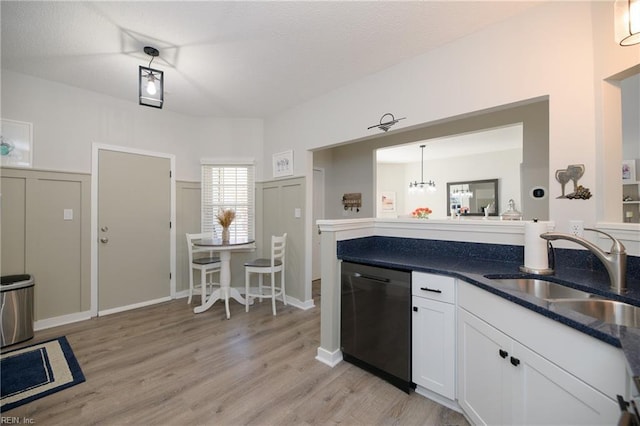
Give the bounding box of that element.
[457,282,626,425]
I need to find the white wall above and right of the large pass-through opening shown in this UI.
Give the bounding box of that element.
[264,2,640,231]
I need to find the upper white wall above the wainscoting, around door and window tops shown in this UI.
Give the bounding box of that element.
[2,70,263,181]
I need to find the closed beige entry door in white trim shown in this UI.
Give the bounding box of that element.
[97,149,171,314]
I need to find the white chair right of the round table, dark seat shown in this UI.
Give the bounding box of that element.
[244,233,287,315]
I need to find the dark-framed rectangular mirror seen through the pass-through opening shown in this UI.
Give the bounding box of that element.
[447,179,500,216]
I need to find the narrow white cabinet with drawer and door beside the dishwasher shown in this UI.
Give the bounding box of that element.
[411,272,456,400]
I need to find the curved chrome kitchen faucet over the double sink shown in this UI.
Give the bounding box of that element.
[540,228,627,294]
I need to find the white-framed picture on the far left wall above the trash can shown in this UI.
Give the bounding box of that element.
[0,118,33,167]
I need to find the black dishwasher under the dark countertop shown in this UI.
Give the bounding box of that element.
[340,262,411,392]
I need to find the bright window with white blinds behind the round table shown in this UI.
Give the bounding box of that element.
[201,163,255,239]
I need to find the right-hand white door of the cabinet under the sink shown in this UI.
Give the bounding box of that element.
[509,342,620,425]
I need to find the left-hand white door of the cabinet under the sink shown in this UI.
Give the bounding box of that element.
[458,309,511,425]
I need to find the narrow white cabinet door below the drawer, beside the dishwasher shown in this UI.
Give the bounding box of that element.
[412,297,456,400]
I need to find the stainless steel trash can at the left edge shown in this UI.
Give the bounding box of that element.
[0,274,35,348]
